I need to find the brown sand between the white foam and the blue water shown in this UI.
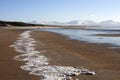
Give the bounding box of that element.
[32,31,120,80]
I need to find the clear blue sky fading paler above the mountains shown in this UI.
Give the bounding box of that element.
[0,0,120,22]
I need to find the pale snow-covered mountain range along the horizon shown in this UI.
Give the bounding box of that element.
[32,20,120,26]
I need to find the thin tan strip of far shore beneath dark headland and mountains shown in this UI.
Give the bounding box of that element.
[0,26,120,31]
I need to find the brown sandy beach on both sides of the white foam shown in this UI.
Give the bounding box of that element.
[0,29,120,80]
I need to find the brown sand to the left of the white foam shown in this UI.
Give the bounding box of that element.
[0,29,40,80]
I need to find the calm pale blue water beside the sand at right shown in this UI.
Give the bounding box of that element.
[37,28,120,47]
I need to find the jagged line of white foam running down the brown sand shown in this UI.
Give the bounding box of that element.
[10,31,95,80]
